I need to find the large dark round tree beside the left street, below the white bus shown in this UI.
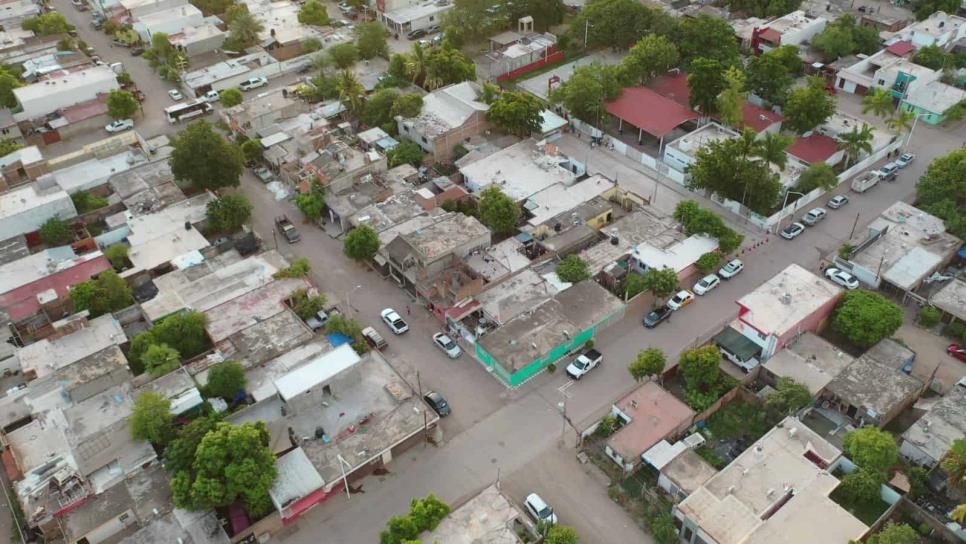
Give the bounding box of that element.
[169,121,245,190]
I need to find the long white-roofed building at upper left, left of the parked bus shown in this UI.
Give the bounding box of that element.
[13,66,120,121]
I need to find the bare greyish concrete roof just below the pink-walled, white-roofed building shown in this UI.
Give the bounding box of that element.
[765,332,855,395]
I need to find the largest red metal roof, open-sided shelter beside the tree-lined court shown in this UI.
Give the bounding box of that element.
[607,87,698,138]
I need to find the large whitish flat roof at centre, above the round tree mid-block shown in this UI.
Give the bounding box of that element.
[460,140,577,202]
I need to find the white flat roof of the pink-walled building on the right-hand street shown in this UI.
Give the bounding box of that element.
[738,264,842,335]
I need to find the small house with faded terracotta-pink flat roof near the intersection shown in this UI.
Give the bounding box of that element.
[607,381,694,464]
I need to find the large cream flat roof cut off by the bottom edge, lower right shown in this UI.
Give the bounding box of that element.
[677,417,868,544]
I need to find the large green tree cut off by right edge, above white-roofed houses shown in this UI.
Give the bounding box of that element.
[916,149,966,239]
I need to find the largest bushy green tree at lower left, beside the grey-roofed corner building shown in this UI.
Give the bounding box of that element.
[171,421,277,519]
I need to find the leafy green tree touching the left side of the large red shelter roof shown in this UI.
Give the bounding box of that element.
[550,61,624,125]
